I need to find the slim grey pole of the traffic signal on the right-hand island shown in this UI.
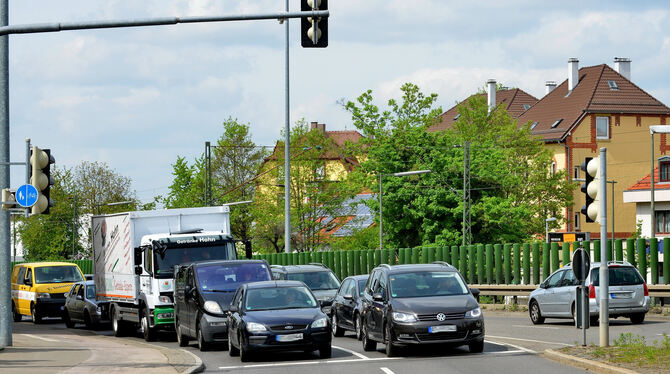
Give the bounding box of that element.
[598,148,612,347]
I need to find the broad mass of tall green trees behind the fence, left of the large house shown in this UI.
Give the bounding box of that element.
[345,83,572,247]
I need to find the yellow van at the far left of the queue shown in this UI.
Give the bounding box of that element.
[12,262,84,323]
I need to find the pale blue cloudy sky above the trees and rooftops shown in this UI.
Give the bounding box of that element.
[9,0,670,202]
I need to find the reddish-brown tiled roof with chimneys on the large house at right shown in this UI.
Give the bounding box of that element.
[518,64,670,140]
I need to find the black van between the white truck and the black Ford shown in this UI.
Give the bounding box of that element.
[174,260,272,351]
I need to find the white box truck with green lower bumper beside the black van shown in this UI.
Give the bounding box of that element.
[91,206,237,341]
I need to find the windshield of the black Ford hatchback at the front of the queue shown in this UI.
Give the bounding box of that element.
[245,286,317,311]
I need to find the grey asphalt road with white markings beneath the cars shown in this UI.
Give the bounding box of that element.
[27,311,670,374]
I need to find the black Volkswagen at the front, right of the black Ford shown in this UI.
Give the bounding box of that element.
[361,262,484,357]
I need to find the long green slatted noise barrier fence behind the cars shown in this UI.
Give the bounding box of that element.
[253,238,670,284]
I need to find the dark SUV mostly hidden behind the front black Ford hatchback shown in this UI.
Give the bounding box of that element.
[272,263,340,315]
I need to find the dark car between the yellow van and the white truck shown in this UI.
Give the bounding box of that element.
[63,280,109,328]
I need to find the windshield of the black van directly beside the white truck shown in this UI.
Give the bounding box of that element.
[196,263,270,292]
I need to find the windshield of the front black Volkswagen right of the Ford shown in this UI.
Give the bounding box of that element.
[389,271,468,297]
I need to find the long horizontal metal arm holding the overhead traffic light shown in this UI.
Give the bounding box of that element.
[0,10,330,35]
